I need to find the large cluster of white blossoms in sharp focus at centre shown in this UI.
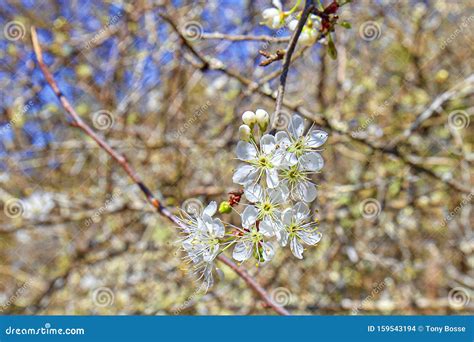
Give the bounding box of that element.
[176,109,328,287]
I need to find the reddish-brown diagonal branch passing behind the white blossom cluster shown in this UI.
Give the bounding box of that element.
[31,27,289,315]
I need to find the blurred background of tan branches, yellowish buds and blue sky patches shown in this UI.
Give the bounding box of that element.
[0,0,474,315]
